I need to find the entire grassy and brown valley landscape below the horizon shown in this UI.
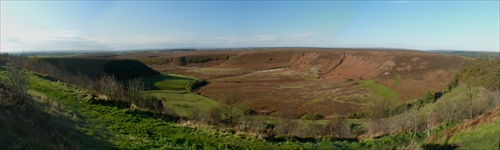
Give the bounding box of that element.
[0,48,500,149]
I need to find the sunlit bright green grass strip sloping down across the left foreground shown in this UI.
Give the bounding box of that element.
[31,73,277,149]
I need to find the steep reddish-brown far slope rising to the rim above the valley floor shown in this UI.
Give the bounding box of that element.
[209,50,465,100]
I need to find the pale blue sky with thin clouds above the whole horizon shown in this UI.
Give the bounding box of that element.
[0,0,500,52]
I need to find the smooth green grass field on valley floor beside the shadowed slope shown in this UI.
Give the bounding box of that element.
[143,74,219,117]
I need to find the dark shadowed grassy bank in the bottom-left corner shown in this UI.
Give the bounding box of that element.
[0,93,113,149]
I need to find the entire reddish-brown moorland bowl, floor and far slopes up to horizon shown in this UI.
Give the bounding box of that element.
[111,48,466,117]
